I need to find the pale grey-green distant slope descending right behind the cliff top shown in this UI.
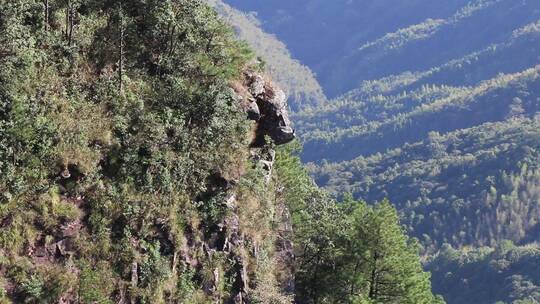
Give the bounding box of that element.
[207,0,326,110]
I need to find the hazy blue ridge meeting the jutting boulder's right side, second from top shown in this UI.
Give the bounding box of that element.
[297,21,540,140]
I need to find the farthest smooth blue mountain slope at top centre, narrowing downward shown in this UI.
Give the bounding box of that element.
[227,0,468,96]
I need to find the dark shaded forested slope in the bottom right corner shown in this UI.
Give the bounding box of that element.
[427,241,540,304]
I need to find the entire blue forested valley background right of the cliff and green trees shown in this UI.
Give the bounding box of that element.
[221,0,540,304]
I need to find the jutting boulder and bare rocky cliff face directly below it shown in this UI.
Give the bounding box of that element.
[190,71,295,304]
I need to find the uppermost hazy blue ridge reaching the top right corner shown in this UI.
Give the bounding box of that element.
[321,0,540,93]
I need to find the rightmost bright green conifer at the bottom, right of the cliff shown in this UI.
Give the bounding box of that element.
[343,201,443,304]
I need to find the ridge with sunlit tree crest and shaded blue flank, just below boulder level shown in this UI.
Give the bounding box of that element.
[304,66,540,161]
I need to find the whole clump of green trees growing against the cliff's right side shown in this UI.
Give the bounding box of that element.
[276,147,444,304]
